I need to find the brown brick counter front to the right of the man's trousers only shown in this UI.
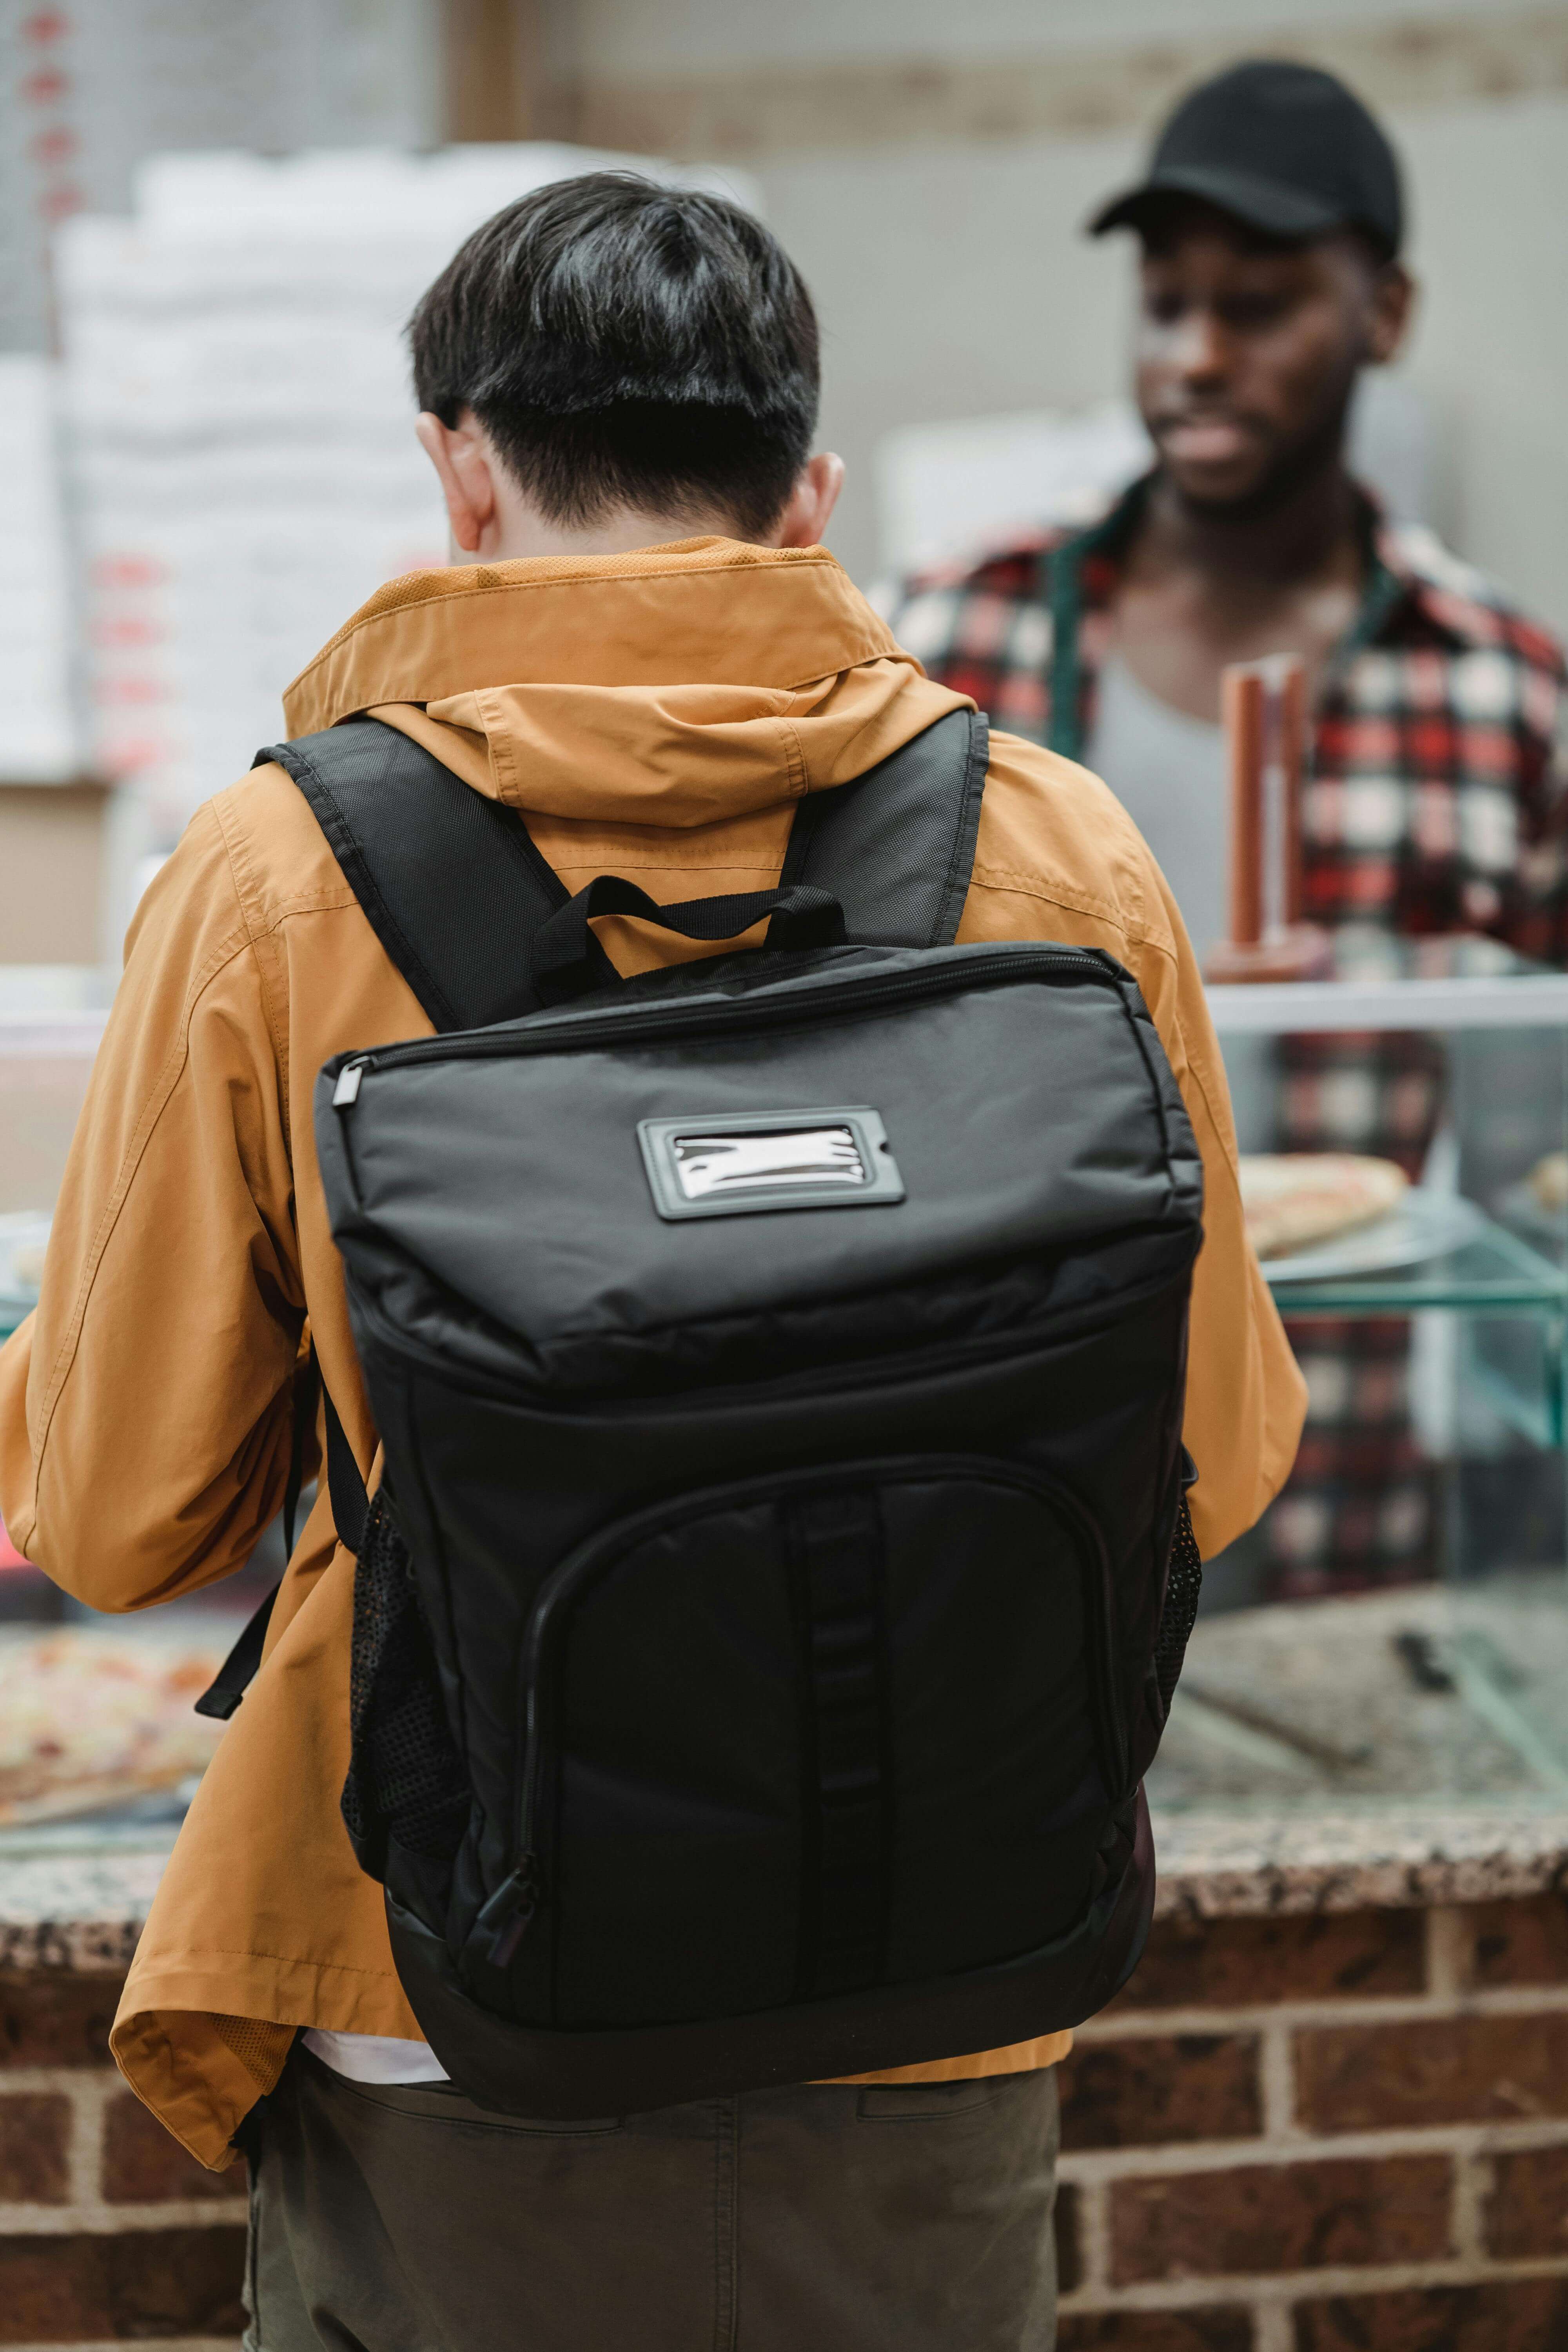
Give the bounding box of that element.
[1060,1896,1568,2352]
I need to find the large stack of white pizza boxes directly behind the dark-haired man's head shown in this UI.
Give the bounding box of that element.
[56,146,748,884]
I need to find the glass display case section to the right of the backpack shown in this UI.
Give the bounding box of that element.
[1152,936,1568,1813]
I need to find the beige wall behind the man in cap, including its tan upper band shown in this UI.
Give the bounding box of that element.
[545,0,1568,630]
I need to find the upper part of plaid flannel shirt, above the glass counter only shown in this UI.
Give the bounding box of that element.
[893,477,1568,964]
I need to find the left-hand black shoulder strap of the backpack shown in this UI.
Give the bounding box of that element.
[254,720,613,1030]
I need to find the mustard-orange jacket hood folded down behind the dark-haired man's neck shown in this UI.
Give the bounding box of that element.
[285,539,966,830]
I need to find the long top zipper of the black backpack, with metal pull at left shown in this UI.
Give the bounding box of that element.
[332,948,1122,1110]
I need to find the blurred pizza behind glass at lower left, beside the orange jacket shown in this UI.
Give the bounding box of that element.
[0,1630,223,1828]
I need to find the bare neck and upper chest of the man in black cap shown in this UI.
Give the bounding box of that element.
[1133,452,1361,595]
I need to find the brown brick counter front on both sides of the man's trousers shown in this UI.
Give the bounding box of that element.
[0,1896,1568,2352]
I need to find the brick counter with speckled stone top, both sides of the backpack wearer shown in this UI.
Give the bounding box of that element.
[0,1590,1568,2352]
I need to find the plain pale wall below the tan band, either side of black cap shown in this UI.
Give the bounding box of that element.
[780,96,1568,612]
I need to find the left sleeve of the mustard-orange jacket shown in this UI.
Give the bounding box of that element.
[0,809,303,1609]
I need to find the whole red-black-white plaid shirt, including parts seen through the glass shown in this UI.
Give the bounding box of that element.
[893,477,1568,1595]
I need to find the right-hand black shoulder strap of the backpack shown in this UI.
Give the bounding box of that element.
[780,710,990,948]
